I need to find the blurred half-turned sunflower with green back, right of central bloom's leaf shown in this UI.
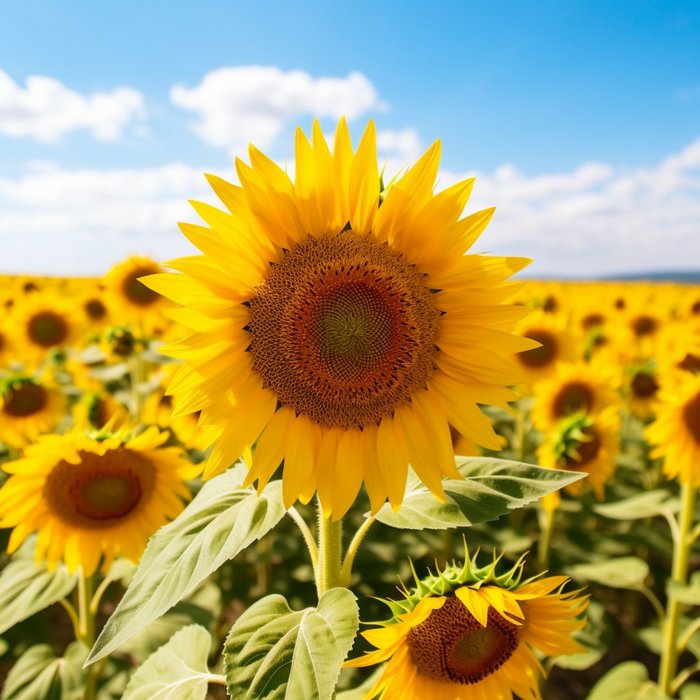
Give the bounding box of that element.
[537,406,620,504]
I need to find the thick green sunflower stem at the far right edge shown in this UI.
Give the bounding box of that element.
[659,484,697,697]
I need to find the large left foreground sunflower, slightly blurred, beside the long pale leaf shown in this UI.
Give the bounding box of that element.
[0,427,199,575]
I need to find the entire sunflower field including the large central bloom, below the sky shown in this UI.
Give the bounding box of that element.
[0,120,700,700]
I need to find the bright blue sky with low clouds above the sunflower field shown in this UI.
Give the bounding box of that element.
[0,0,700,276]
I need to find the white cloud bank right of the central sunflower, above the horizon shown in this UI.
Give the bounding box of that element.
[440,139,700,276]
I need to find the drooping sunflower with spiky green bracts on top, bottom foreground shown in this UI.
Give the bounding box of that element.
[345,561,587,700]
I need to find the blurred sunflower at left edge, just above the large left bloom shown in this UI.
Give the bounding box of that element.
[0,374,66,447]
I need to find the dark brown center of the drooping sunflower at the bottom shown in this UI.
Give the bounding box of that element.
[406,597,520,685]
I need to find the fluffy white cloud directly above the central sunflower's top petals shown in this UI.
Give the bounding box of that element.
[170,66,383,155]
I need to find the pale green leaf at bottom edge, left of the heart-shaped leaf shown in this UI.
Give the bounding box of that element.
[122,625,211,700]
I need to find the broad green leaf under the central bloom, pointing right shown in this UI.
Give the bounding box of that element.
[375,457,586,530]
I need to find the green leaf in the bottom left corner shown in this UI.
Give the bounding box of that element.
[2,642,88,700]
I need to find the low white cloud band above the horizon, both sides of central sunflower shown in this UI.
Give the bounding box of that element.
[0,132,700,276]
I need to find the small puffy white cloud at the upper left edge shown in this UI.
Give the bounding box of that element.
[0,69,146,143]
